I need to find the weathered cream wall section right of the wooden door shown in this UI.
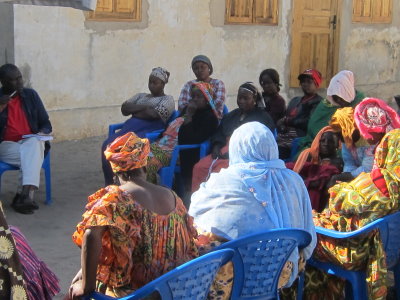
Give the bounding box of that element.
[339,1,400,105]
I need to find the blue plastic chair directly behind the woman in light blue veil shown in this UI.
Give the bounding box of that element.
[215,229,311,300]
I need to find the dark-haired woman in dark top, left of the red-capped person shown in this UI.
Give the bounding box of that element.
[258,69,286,124]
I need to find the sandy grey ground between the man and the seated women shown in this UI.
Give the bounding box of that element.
[0,137,105,299]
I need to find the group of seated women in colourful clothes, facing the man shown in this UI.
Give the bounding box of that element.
[69,56,400,299]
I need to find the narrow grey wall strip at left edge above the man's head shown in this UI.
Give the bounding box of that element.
[0,3,14,65]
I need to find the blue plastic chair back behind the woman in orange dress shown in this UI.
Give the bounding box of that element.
[85,249,234,300]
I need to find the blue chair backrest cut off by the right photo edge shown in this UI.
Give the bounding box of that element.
[375,212,400,268]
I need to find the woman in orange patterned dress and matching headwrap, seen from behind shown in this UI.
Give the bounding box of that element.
[69,132,197,299]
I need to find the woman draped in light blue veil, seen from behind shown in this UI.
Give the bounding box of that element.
[189,122,316,299]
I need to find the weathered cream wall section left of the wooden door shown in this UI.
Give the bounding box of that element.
[14,0,289,139]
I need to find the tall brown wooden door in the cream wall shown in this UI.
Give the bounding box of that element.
[290,0,341,87]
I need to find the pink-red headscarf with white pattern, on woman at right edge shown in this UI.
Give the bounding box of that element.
[354,98,400,139]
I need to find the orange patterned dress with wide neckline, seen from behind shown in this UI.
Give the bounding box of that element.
[72,185,198,296]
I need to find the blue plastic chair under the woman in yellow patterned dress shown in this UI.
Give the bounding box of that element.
[307,212,400,300]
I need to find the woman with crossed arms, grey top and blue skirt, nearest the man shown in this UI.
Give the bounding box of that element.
[101,67,175,186]
